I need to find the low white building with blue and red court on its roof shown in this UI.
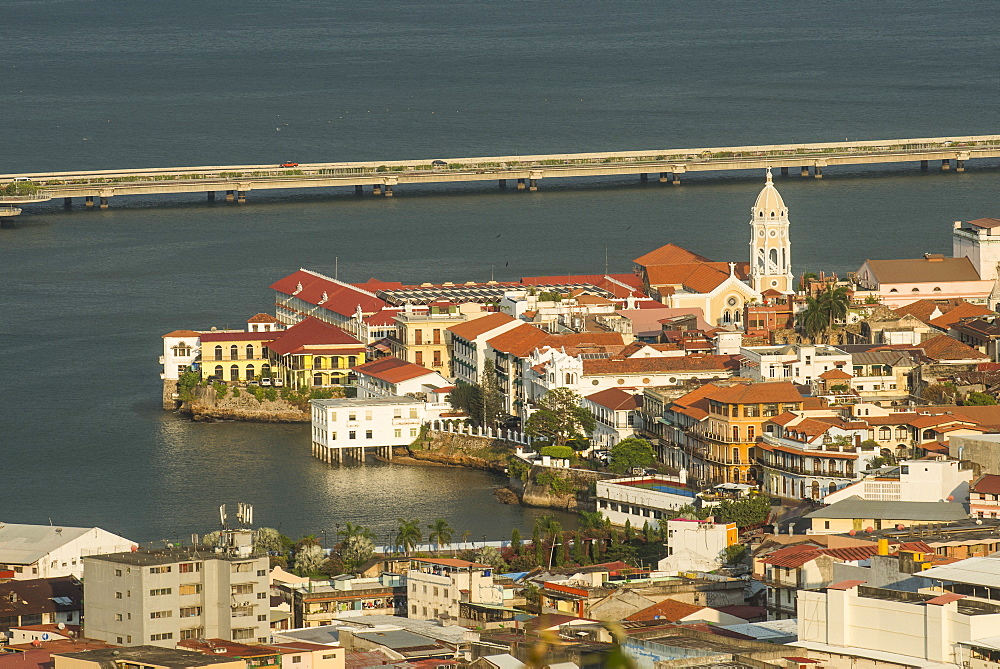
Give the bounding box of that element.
[596,470,695,528]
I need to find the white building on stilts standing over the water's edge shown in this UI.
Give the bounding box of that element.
[309,397,451,462]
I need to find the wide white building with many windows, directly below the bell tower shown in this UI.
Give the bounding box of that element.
[740,344,851,385]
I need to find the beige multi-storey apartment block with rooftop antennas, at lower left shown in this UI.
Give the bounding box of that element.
[84,532,270,648]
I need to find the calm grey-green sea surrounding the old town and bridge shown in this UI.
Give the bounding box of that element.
[0,0,1000,541]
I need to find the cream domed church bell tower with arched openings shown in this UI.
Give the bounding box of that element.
[750,168,794,294]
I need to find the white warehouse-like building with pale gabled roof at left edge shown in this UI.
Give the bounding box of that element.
[0,523,137,579]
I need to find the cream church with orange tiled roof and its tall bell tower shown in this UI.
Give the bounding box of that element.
[633,170,794,329]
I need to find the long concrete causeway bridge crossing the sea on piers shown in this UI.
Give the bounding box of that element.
[0,135,1000,211]
